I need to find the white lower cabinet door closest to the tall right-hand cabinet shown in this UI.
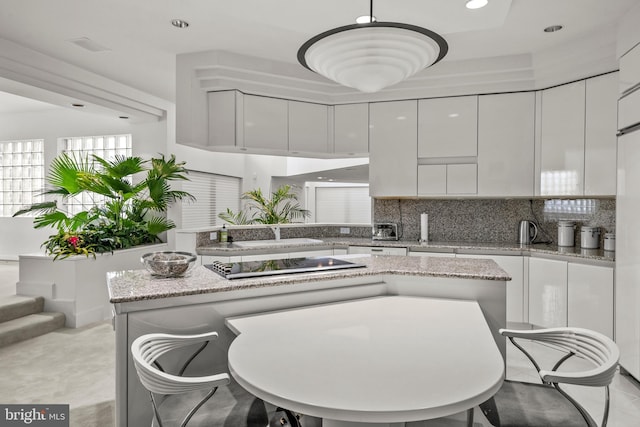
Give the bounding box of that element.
[567,263,613,339]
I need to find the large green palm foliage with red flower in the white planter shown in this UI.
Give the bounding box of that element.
[14,154,195,259]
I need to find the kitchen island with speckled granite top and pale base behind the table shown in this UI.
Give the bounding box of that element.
[107,256,510,427]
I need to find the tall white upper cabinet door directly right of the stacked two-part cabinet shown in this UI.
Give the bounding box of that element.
[478,92,535,197]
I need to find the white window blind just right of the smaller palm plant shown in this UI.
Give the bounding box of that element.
[316,187,371,224]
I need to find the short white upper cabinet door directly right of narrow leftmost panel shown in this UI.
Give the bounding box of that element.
[242,95,289,151]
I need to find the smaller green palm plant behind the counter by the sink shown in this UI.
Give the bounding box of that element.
[218,185,310,225]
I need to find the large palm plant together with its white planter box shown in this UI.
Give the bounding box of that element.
[16,154,194,328]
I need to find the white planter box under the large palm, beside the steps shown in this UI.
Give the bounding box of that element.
[16,243,168,328]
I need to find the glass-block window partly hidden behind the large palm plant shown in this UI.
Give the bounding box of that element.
[62,135,132,215]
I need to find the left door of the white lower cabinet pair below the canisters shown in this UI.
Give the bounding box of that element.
[529,258,567,328]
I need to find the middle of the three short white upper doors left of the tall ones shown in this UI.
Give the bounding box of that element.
[289,101,329,154]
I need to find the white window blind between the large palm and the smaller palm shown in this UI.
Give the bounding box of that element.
[182,171,240,228]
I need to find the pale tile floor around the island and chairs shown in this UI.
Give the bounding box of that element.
[0,261,640,427]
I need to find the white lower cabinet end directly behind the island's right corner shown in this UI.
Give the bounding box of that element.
[456,254,528,323]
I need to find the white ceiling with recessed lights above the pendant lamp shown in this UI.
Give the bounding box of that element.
[0,0,638,105]
